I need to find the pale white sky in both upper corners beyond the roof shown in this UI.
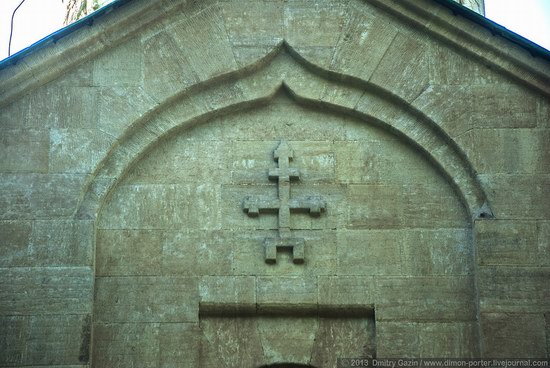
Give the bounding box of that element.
[0,0,550,60]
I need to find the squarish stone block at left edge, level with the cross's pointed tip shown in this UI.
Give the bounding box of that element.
[0,130,50,173]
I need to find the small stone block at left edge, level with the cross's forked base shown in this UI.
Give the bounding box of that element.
[0,221,32,267]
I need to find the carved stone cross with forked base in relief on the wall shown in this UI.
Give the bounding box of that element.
[243,141,326,263]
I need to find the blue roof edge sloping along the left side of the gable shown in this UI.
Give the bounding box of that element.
[0,0,132,70]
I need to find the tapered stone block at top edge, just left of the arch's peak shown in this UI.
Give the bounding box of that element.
[222,1,284,46]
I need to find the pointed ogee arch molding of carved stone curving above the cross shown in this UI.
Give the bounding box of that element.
[76,42,493,223]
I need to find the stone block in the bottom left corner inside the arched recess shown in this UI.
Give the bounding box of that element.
[92,322,161,368]
